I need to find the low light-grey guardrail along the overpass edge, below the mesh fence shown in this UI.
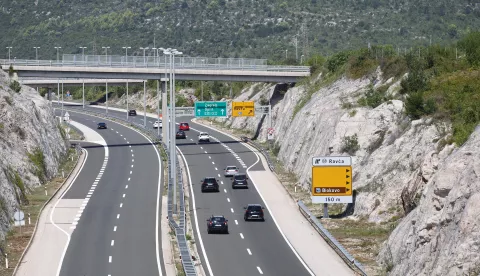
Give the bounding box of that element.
[0,58,310,72]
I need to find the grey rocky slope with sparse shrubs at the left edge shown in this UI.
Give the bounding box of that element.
[0,70,67,244]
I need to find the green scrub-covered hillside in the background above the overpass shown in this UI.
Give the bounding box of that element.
[0,0,480,63]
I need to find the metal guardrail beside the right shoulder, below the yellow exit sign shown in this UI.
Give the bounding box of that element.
[298,200,367,276]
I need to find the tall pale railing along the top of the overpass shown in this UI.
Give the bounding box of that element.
[0,56,310,72]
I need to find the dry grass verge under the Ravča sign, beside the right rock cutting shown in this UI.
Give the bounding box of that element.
[197,120,397,275]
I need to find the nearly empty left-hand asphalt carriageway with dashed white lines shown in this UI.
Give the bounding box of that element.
[57,110,165,276]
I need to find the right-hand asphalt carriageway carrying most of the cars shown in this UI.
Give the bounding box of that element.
[65,103,311,276]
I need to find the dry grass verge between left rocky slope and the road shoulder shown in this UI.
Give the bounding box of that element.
[0,149,78,276]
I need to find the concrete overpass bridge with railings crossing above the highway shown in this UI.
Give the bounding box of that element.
[0,55,310,83]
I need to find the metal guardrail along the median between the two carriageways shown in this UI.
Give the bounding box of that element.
[64,106,197,276]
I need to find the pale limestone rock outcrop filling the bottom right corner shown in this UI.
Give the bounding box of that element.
[379,129,480,275]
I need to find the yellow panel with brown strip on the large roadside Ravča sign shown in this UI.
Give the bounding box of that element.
[312,166,352,196]
